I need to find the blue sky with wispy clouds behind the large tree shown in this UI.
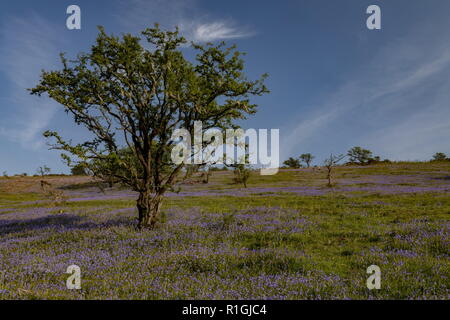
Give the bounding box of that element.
[0,0,450,174]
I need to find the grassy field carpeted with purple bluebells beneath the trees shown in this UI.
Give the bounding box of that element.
[0,162,450,299]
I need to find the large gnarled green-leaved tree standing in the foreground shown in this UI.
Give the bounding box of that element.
[30,24,268,229]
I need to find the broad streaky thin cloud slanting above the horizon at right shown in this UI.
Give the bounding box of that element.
[282,24,450,160]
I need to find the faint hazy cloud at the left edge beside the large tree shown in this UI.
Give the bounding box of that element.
[0,15,58,149]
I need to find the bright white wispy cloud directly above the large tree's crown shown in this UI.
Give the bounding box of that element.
[117,0,254,42]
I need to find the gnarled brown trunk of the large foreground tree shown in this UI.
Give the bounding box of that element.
[137,192,163,230]
